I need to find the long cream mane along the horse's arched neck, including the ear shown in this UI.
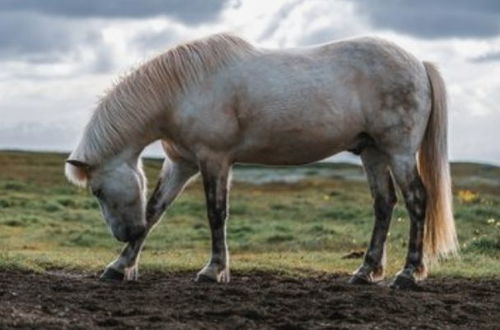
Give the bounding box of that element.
[65,33,256,185]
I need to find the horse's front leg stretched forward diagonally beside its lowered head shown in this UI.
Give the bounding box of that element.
[101,159,198,280]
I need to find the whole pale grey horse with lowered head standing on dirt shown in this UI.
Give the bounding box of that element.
[65,34,457,287]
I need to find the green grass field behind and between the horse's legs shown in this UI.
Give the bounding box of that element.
[0,151,500,277]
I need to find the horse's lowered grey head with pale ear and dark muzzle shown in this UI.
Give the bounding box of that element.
[66,159,146,242]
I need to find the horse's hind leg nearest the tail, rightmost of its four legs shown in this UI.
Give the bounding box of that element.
[391,154,427,288]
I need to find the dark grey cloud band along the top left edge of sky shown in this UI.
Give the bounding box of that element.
[0,0,226,24]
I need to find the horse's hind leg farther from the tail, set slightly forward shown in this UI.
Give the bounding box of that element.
[349,147,396,284]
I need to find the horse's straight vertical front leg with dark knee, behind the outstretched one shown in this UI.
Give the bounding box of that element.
[196,160,231,283]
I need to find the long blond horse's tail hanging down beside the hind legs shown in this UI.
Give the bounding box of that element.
[418,62,458,261]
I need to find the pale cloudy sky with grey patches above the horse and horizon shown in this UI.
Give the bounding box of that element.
[0,0,500,165]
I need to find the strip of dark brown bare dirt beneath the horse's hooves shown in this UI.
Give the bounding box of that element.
[0,271,500,329]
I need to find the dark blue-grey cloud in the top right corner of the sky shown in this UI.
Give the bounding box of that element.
[353,0,500,38]
